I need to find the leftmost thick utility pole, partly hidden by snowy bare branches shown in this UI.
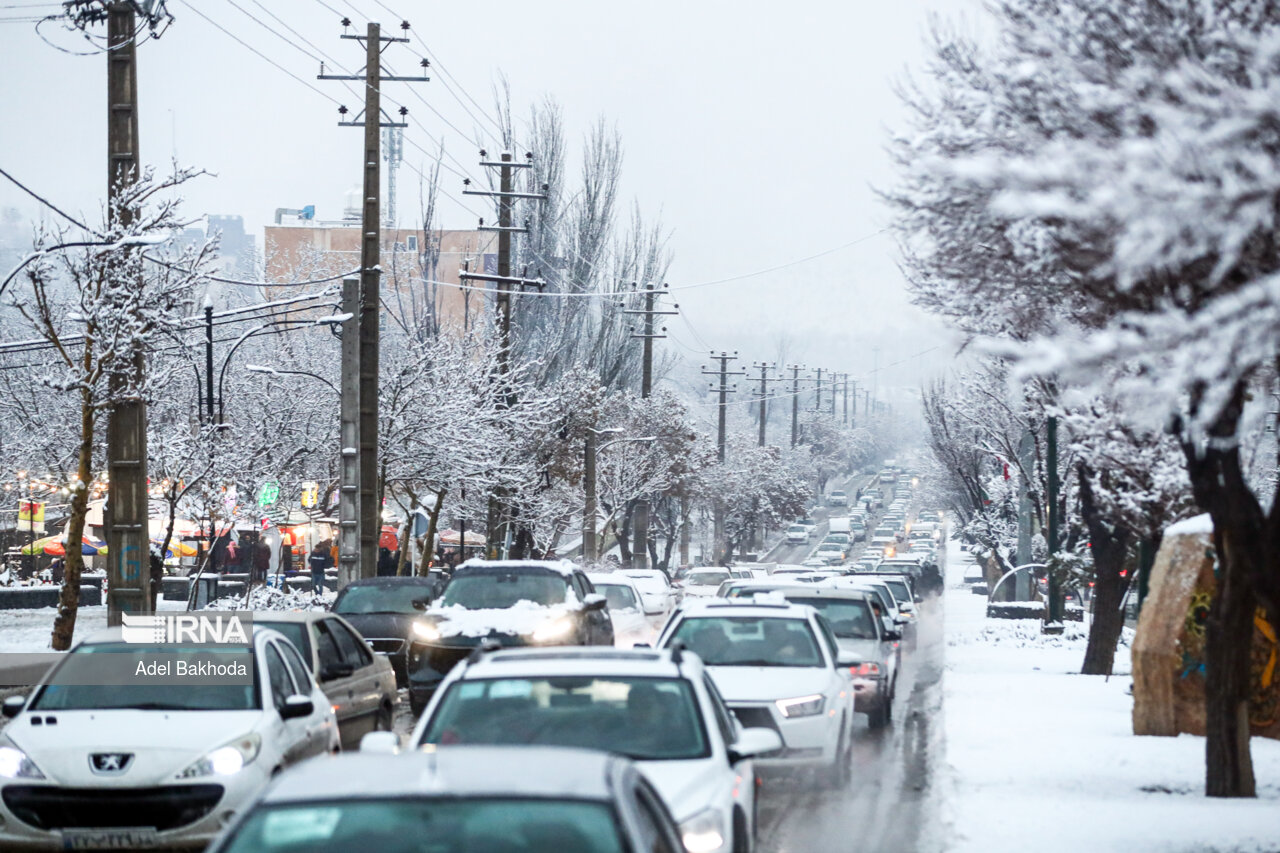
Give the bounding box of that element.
[106,1,151,625]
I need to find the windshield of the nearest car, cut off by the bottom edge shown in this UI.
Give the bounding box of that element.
[223,795,623,853]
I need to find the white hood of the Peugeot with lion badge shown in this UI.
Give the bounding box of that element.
[4,708,264,788]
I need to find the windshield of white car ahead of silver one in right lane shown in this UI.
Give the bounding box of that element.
[671,616,823,666]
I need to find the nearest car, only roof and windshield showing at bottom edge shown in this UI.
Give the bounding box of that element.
[207,747,682,853]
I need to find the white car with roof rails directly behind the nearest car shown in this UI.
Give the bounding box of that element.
[411,648,782,853]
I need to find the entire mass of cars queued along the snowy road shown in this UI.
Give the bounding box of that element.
[0,458,943,853]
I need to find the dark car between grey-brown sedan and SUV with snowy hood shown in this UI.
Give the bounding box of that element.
[332,576,440,686]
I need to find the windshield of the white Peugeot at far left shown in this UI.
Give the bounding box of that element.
[29,643,261,711]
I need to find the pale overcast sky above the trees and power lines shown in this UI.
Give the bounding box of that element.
[0,0,977,394]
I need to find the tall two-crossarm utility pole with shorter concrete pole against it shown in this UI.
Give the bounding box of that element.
[317,18,429,588]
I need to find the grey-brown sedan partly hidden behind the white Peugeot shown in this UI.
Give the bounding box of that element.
[253,611,397,749]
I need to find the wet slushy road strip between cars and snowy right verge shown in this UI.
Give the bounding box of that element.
[758,598,943,853]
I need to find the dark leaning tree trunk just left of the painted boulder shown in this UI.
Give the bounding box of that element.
[1078,465,1133,675]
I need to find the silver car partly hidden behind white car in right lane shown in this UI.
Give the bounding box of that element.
[782,589,900,729]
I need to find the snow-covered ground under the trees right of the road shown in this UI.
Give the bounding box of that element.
[942,542,1280,853]
